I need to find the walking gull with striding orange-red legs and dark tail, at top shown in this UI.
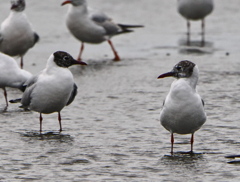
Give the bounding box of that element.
[62,0,143,61]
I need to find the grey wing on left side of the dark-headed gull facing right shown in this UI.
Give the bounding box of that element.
[21,75,38,108]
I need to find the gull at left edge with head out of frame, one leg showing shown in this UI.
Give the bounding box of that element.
[0,53,32,110]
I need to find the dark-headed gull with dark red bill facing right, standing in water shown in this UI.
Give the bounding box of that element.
[11,51,86,132]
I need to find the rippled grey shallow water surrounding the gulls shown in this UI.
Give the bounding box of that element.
[0,0,240,181]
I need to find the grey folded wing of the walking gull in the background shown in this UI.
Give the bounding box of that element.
[90,10,121,35]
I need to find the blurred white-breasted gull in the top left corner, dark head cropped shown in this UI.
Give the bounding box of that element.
[0,0,39,68]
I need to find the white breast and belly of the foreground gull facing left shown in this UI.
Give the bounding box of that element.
[160,79,206,134]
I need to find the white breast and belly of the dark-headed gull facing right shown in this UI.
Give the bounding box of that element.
[30,67,74,114]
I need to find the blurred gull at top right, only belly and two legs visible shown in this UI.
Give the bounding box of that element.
[178,0,213,46]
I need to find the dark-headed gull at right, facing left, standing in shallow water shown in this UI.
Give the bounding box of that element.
[158,61,207,154]
